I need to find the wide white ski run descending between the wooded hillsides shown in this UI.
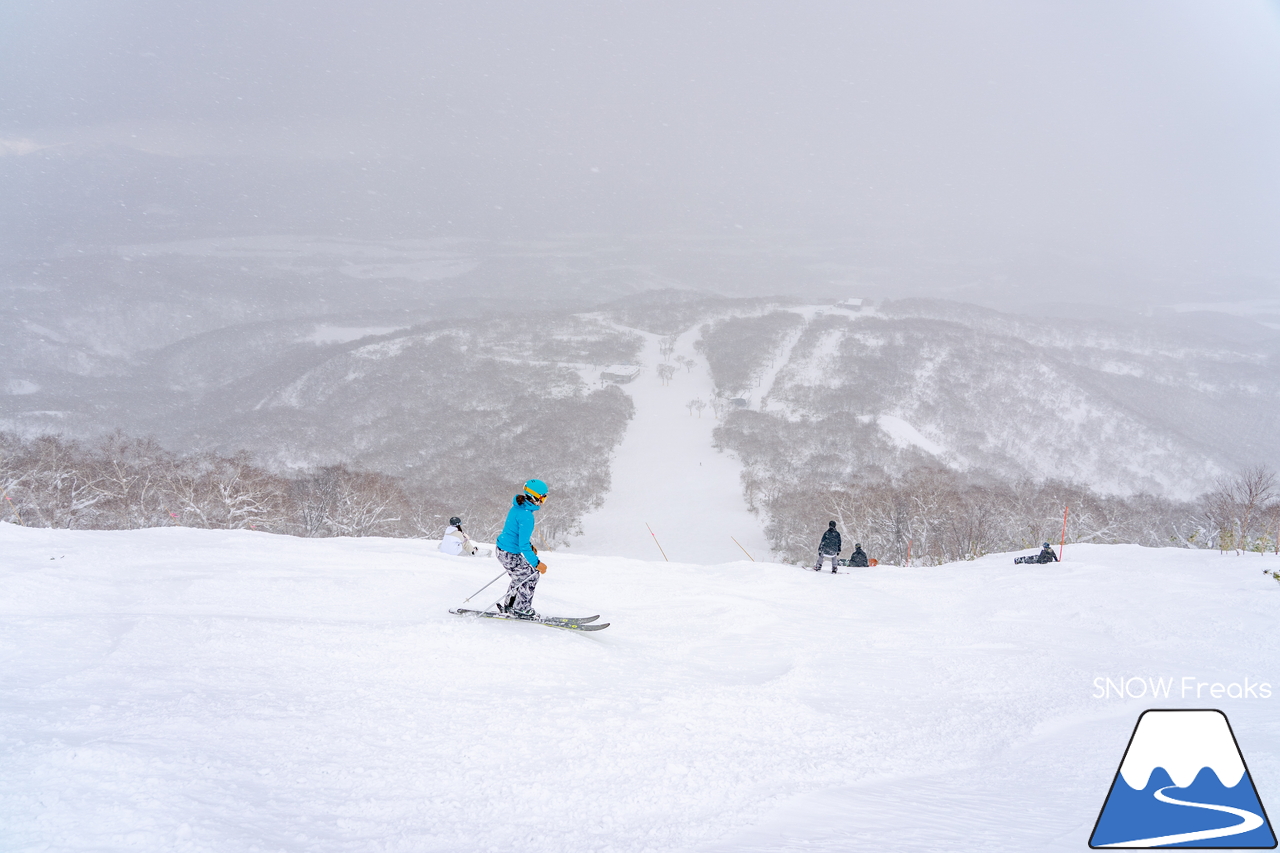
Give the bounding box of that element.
[570,328,769,565]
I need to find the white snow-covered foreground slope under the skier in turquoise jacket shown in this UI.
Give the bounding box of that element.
[0,524,1280,853]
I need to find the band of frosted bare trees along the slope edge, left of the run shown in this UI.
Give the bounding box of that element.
[0,433,622,547]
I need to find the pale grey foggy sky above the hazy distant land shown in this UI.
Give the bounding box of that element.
[0,0,1280,306]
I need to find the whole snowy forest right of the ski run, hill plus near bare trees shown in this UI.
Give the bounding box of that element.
[700,301,1280,565]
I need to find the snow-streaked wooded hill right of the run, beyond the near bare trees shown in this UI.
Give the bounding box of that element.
[708,300,1280,497]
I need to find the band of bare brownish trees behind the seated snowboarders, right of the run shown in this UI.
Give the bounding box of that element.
[754,466,1280,565]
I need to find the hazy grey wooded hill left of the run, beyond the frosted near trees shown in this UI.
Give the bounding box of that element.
[0,308,640,540]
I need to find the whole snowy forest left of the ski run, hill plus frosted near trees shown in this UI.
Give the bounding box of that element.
[0,308,637,543]
